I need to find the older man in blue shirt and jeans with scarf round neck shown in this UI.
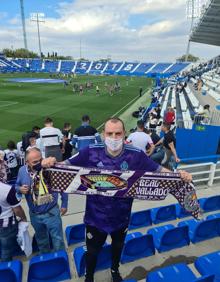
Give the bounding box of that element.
[16,148,68,253]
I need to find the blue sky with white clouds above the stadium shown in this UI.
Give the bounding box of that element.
[0,0,220,62]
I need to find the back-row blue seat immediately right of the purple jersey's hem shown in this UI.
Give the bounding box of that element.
[129,210,152,230]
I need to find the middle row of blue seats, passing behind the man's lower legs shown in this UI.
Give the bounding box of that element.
[73,216,220,276]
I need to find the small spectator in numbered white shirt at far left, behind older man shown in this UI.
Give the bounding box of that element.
[4,141,18,180]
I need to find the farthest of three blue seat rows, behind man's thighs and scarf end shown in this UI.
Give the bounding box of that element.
[65,196,220,245]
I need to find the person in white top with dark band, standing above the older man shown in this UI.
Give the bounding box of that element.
[40,117,65,161]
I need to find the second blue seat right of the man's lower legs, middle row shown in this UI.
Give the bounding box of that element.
[148,224,190,253]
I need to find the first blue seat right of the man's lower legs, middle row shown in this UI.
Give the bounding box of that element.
[121,232,155,263]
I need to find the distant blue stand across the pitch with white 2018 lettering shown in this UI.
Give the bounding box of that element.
[0,53,189,76]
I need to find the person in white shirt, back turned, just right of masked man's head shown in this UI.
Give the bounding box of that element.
[126,120,154,156]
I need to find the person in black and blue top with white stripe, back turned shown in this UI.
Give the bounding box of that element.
[72,115,102,151]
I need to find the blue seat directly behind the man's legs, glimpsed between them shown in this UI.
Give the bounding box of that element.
[73,244,111,277]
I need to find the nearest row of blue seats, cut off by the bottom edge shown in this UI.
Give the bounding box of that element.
[0,251,220,282]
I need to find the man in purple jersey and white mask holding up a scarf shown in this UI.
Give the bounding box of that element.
[42,118,191,282]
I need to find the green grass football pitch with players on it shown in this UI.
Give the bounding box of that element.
[0,73,152,147]
